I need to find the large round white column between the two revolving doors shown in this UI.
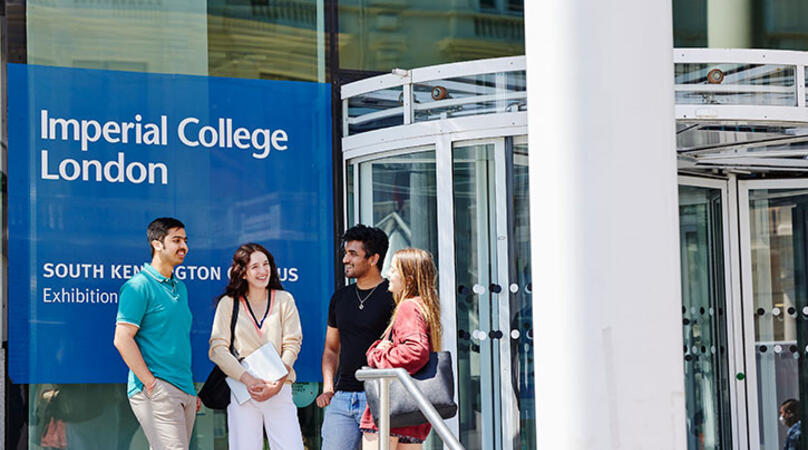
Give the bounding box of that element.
[525,0,686,450]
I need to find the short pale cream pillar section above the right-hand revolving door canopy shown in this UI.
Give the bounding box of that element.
[707,0,752,48]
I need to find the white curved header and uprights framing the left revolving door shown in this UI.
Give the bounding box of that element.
[342,125,527,448]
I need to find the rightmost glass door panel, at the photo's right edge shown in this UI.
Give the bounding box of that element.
[746,189,808,450]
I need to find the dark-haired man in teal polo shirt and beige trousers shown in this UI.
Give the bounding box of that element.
[115,217,198,450]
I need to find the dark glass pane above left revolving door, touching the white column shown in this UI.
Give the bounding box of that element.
[338,0,525,72]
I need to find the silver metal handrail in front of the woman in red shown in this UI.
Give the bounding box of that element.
[355,367,465,450]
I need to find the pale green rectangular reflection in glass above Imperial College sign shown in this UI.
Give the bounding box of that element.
[26,0,208,75]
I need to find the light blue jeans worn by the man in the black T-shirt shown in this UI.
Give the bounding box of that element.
[320,391,367,450]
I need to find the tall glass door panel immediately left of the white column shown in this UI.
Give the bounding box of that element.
[452,137,536,449]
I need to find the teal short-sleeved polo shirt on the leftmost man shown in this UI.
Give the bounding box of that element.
[116,264,196,397]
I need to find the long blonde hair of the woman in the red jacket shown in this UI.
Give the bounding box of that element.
[382,248,443,351]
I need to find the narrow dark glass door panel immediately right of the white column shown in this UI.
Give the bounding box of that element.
[679,186,731,450]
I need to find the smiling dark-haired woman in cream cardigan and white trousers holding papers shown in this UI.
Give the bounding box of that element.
[209,243,303,450]
